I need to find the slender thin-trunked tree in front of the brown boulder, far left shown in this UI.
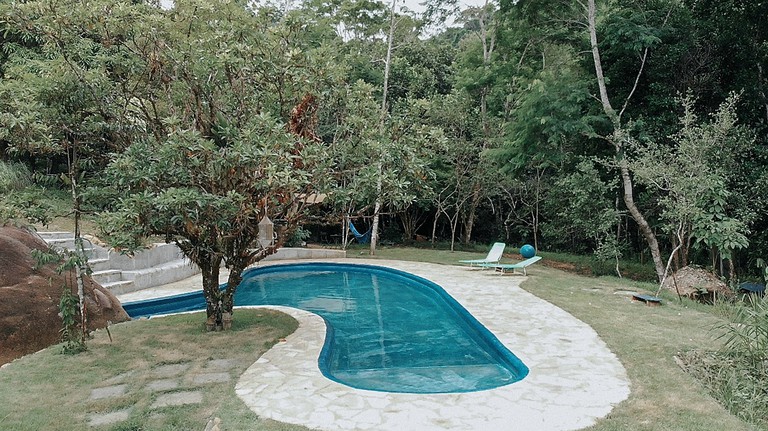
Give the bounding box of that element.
[0,2,141,345]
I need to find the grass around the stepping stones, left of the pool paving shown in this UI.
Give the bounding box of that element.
[0,309,306,431]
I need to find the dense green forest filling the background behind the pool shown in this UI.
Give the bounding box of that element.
[0,0,768,281]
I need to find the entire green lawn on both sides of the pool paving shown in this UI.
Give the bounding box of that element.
[0,247,757,431]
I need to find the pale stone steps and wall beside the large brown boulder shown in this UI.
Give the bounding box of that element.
[38,232,200,295]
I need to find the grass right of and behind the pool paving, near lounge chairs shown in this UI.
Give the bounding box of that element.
[348,248,754,431]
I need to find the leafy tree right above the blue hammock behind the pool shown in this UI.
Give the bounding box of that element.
[330,81,444,250]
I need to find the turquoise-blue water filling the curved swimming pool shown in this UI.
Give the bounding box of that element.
[124,263,528,393]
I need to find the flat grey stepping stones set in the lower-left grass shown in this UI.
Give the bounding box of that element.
[88,359,237,429]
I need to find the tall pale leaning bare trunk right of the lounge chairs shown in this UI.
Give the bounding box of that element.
[587,0,666,283]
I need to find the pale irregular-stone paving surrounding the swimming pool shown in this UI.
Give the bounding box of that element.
[117,259,630,431]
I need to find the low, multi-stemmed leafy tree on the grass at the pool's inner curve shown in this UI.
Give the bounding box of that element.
[102,115,321,325]
